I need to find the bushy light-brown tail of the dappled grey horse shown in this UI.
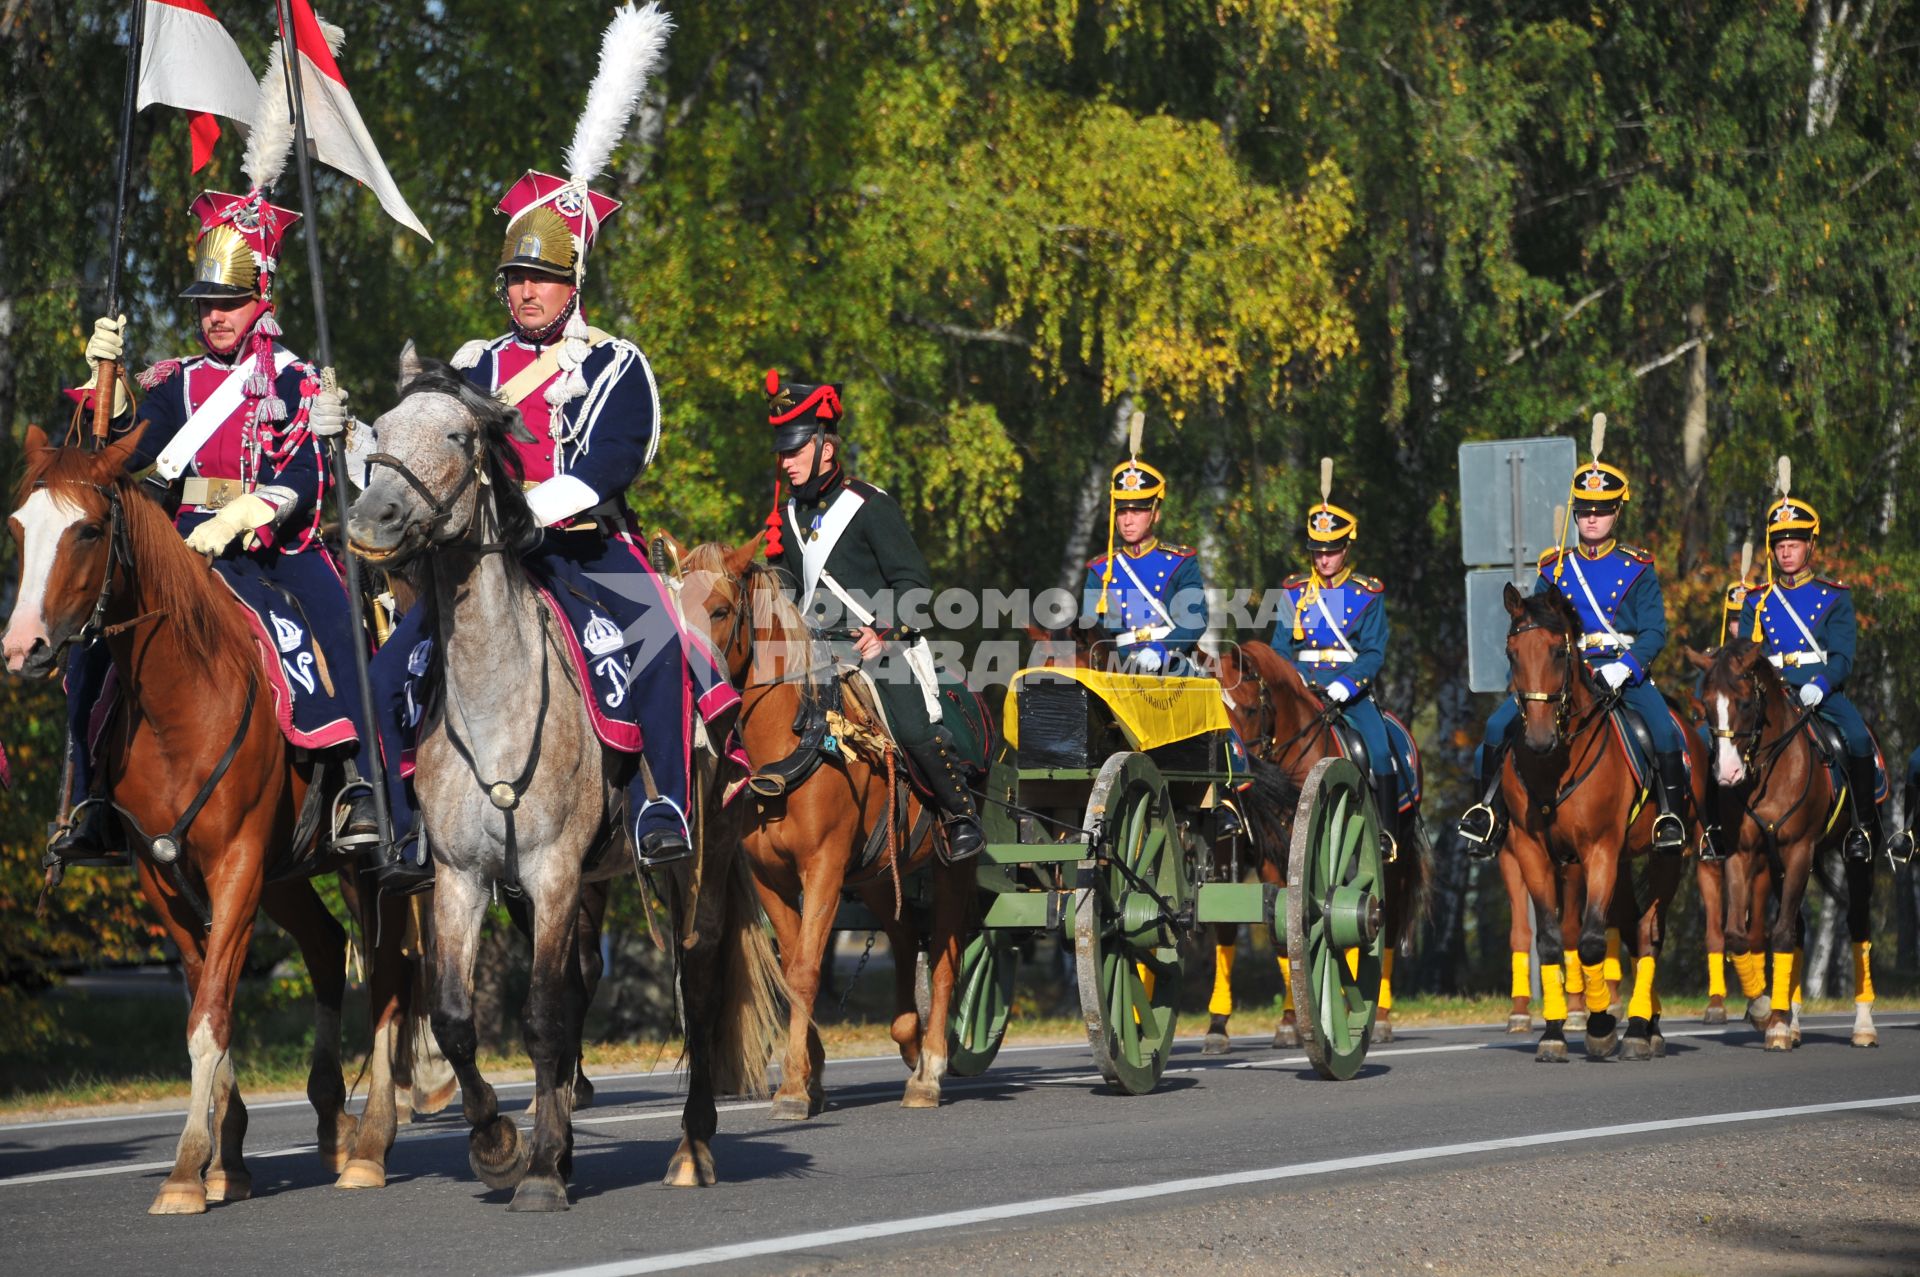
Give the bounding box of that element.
[712,849,787,1095]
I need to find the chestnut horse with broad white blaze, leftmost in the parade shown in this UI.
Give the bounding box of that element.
[6,424,413,1216]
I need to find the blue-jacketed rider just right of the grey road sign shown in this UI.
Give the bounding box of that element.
[1455,426,1688,858]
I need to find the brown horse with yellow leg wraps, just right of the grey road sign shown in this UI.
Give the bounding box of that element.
[1501,586,1707,1062]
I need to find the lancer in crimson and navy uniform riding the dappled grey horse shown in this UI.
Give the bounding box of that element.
[353,117,739,887]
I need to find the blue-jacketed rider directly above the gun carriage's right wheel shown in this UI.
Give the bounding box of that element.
[1273,457,1400,837]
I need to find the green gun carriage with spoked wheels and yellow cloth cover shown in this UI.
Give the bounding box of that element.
[837,668,1382,1095]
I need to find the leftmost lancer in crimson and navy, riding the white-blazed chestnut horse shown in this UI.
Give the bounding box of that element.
[48,148,380,862]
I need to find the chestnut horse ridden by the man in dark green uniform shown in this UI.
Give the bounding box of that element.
[674,540,973,1121]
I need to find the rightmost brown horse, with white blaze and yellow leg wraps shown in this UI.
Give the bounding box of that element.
[1688,639,1880,1050]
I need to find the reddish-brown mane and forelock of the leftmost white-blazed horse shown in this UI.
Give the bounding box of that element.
[21,447,259,676]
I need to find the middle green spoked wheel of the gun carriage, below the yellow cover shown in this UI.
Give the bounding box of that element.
[1073,753,1194,1095]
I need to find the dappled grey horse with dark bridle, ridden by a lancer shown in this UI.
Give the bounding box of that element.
[348,342,780,1210]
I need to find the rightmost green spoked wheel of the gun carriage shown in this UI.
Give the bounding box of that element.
[1286,759,1382,1081]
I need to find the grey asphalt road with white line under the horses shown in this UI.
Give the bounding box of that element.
[0,1014,1920,1277]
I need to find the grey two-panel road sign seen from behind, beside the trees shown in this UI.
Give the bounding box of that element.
[1459,438,1576,691]
